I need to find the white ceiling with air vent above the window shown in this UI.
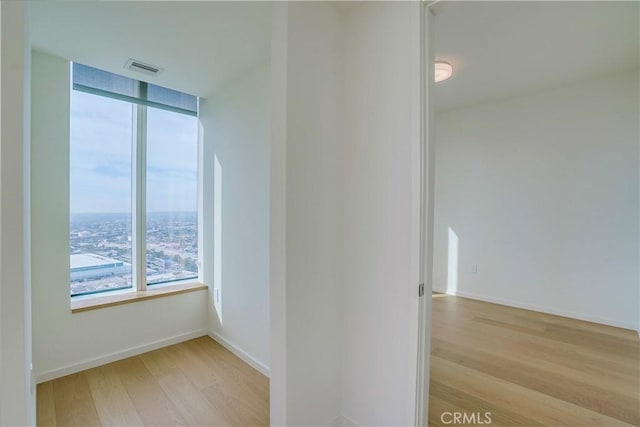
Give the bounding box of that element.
[29,0,271,97]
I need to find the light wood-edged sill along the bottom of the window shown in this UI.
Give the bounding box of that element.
[71,282,208,313]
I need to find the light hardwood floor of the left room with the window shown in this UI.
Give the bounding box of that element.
[37,337,269,427]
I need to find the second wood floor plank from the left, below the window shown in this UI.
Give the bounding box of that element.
[52,372,101,427]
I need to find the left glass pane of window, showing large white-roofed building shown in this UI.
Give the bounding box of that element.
[69,91,134,295]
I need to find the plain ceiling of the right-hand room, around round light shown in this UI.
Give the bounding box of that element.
[434,1,640,111]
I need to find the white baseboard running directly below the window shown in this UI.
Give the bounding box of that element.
[36,329,207,384]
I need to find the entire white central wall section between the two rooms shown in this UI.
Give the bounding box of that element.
[271,2,419,425]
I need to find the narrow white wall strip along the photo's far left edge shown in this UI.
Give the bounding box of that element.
[0,2,35,426]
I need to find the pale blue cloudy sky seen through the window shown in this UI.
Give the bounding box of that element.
[70,90,198,213]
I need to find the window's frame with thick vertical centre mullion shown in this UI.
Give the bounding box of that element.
[69,63,202,298]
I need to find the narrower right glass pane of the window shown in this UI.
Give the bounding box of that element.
[146,108,198,285]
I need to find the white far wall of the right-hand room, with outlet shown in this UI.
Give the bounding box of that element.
[434,70,640,329]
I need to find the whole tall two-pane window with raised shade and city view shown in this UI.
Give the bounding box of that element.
[69,64,198,296]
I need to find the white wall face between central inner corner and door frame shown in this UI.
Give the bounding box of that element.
[342,2,428,425]
